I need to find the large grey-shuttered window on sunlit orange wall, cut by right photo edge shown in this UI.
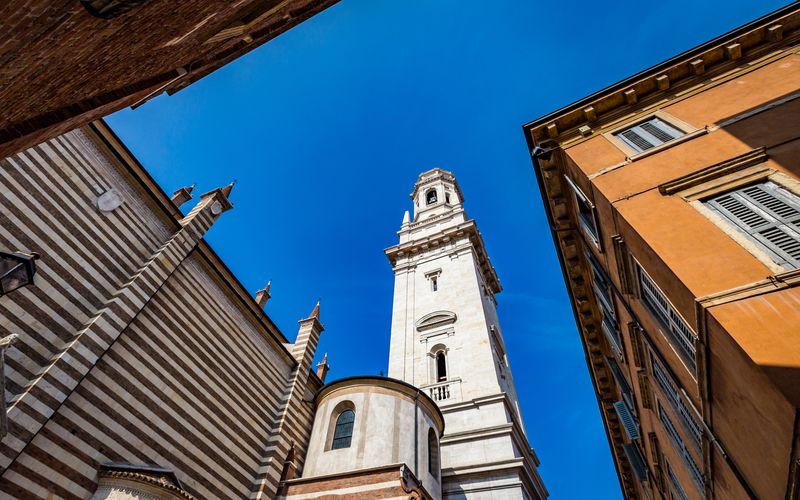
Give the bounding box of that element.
[704,181,800,269]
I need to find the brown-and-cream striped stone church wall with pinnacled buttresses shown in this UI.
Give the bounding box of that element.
[0,123,320,498]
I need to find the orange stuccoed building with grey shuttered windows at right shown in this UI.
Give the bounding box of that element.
[524,3,800,499]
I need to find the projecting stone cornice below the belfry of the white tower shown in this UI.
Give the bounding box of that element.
[384,220,503,294]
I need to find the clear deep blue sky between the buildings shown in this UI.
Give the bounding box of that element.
[108,0,784,499]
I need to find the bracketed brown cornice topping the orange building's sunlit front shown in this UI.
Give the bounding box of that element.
[523,2,800,145]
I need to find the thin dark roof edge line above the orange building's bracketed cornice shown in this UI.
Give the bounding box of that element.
[522,0,800,135]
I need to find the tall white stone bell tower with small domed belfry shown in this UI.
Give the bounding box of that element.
[386,168,547,499]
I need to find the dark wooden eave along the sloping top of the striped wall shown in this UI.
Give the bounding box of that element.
[82,120,297,365]
